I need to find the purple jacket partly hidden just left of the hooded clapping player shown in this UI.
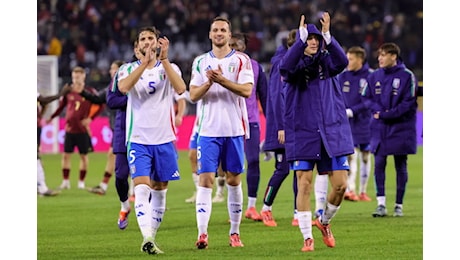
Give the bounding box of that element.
[264,45,287,151]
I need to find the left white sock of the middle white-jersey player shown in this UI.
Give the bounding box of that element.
[195,186,212,236]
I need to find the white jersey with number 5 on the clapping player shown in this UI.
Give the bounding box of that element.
[118,61,182,145]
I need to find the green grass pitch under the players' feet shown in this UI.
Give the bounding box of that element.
[37,146,423,260]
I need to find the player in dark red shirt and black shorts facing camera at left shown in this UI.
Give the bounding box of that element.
[47,66,104,189]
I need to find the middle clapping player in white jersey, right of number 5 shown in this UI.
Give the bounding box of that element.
[190,17,254,249]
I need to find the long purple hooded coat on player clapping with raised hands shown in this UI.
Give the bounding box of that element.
[280,24,354,161]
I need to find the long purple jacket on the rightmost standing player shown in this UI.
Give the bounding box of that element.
[362,60,418,155]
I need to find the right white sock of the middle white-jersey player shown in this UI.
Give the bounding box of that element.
[227,183,243,235]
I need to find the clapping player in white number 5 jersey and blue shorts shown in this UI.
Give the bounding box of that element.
[118,26,186,254]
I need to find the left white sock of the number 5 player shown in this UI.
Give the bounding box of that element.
[134,184,152,238]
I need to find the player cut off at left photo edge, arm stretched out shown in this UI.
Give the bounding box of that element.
[37,84,71,197]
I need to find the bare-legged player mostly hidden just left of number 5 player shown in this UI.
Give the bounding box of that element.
[80,60,123,195]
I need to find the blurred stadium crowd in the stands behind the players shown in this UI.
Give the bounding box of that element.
[37,0,423,97]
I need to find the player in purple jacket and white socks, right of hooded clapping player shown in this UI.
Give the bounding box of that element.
[339,46,373,201]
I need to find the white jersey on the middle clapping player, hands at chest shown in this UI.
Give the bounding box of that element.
[190,50,254,138]
